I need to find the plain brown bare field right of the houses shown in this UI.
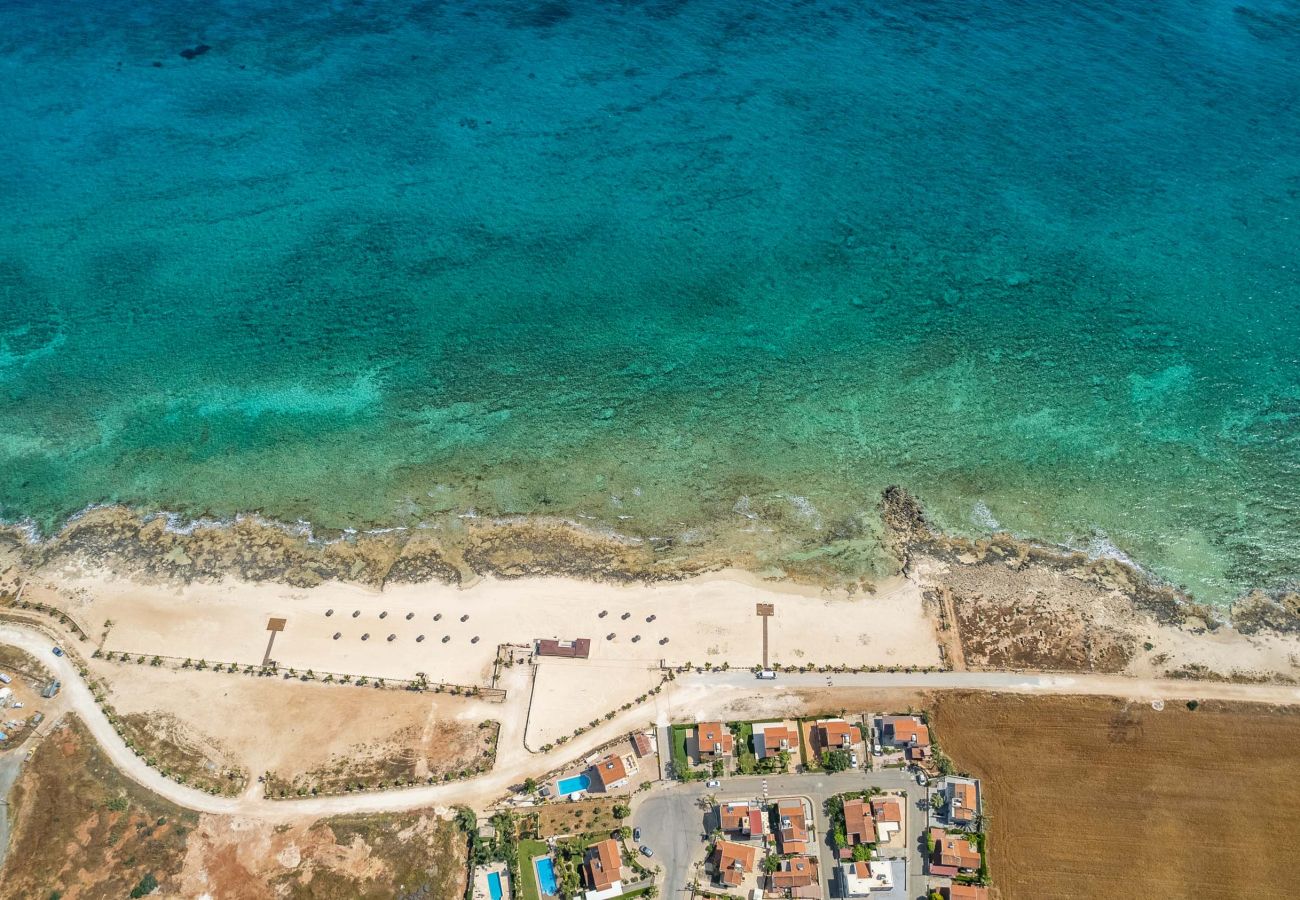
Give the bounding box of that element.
[930,693,1300,900]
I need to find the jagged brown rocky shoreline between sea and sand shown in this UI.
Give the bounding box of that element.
[0,488,1300,635]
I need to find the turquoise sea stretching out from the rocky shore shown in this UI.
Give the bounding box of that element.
[0,0,1300,601]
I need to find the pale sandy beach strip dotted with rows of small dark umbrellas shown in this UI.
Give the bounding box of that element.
[32,572,940,681]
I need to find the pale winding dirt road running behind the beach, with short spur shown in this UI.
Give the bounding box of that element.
[0,623,1300,821]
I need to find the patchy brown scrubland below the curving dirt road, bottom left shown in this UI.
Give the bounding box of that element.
[0,719,467,900]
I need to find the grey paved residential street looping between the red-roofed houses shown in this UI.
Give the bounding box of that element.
[632,769,926,897]
